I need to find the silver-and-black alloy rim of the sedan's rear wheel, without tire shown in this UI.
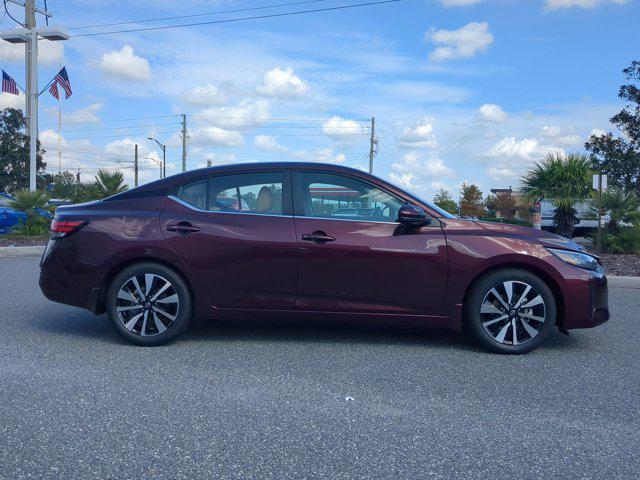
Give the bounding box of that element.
[116,273,180,337]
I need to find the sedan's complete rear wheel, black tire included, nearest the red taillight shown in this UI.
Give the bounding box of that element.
[105,262,193,346]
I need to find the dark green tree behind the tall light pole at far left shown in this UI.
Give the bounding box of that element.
[0,108,47,192]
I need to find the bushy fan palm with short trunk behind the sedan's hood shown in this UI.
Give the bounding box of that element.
[522,153,592,238]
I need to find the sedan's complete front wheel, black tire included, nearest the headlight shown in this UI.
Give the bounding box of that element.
[464,268,557,355]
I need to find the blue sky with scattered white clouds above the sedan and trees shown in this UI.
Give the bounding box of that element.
[0,0,640,200]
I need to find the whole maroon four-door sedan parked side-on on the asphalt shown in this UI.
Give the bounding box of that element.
[40,163,609,353]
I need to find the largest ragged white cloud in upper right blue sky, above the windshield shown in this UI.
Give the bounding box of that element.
[425,22,493,61]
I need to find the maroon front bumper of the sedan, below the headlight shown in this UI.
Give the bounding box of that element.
[562,274,610,330]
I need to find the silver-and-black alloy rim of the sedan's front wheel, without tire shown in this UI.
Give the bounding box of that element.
[480,281,546,346]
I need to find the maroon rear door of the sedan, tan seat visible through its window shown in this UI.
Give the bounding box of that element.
[161,171,298,309]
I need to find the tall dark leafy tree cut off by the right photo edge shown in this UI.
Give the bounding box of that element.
[585,61,640,194]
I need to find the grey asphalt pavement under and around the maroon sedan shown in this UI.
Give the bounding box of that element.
[0,257,640,480]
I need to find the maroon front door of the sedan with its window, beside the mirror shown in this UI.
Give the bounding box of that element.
[293,170,447,315]
